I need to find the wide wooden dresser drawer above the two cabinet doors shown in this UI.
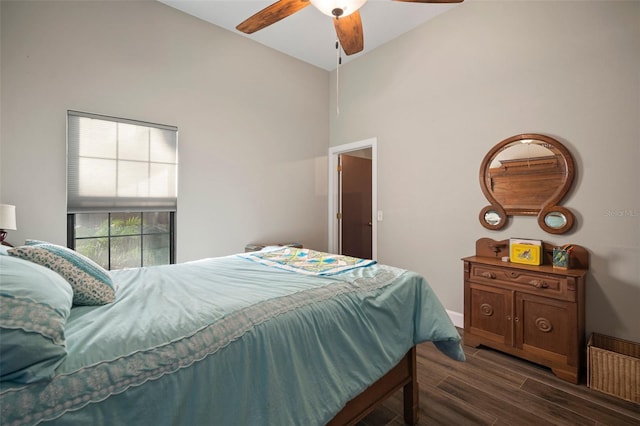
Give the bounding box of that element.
[469,264,569,299]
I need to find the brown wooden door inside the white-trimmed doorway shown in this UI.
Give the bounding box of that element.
[338,154,373,259]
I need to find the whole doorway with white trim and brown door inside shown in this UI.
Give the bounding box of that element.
[329,138,380,259]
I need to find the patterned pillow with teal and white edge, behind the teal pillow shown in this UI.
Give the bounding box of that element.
[9,243,116,305]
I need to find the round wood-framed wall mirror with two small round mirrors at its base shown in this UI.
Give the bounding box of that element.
[480,133,575,234]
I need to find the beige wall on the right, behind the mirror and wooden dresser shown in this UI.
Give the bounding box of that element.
[329,1,640,341]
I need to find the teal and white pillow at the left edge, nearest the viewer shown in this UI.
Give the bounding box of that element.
[0,256,73,383]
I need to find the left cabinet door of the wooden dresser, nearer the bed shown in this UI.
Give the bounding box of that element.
[466,283,513,346]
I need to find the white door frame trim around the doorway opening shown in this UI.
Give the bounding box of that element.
[328,137,378,259]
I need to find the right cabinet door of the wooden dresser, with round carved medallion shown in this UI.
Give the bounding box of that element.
[514,293,577,364]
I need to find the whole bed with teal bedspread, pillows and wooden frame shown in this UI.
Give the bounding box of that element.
[0,241,464,426]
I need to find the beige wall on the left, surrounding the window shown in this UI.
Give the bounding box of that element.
[0,0,329,261]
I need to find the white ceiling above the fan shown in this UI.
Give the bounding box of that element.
[159,0,460,71]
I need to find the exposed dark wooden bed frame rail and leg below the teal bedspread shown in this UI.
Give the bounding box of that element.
[328,346,419,426]
